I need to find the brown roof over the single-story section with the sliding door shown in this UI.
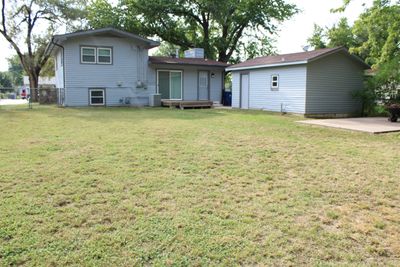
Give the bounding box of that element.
[149,57,229,68]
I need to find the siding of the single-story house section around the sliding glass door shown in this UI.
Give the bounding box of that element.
[149,65,224,103]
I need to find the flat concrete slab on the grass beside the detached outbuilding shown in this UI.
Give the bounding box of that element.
[298,117,400,134]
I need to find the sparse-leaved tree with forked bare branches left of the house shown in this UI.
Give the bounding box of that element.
[0,0,84,101]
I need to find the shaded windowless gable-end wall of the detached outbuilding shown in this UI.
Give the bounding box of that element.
[306,52,363,115]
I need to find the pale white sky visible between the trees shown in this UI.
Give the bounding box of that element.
[0,0,373,71]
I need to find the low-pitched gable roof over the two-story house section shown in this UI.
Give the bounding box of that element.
[52,27,160,48]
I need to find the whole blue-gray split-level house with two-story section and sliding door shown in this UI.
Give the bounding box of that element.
[47,28,227,106]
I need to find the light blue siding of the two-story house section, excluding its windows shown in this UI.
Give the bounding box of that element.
[64,36,149,106]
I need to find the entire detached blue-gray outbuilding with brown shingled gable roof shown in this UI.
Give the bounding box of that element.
[227,47,369,116]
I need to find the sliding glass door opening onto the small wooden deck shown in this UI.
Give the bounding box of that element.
[157,70,182,100]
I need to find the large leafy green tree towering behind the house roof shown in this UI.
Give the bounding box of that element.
[88,0,297,62]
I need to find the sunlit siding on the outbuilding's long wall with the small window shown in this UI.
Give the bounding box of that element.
[232,65,307,114]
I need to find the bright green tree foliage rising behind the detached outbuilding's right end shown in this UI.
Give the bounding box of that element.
[308,0,400,68]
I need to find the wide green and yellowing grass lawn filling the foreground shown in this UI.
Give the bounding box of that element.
[0,106,400,266]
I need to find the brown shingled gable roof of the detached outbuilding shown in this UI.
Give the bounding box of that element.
[227,47,370,71]
